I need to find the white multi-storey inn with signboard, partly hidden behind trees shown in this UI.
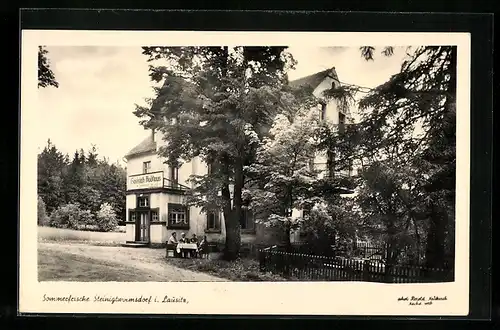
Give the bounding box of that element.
[125,68,354,244]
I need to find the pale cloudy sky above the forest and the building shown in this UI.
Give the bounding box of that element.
[38,46,405,164]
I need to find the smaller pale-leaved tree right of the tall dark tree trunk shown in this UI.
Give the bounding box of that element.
[244,109,320,247]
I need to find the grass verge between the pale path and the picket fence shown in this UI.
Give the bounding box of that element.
[165,258,289,282]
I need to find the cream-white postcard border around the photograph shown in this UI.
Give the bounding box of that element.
[19,30,470,316]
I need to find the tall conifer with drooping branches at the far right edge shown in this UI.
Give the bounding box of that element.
[328,46,457,268]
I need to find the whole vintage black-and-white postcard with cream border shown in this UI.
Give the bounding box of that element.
[19,30,470,316]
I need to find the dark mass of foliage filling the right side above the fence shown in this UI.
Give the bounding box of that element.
[316,46,457,267]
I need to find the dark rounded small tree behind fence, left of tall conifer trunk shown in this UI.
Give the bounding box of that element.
[356,161,423,270]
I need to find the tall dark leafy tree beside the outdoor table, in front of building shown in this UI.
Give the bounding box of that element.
[135,46,302,260]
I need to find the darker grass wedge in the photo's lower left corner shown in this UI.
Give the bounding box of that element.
[38,250,164,282]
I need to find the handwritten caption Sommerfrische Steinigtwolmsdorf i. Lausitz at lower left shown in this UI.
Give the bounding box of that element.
[42,294,189,304]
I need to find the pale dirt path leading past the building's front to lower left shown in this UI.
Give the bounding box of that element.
[38,242,227,282]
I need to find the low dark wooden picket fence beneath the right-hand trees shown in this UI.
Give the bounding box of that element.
[259,248,453,283]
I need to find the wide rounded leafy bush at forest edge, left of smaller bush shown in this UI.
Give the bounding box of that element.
[50,204,94,229]
